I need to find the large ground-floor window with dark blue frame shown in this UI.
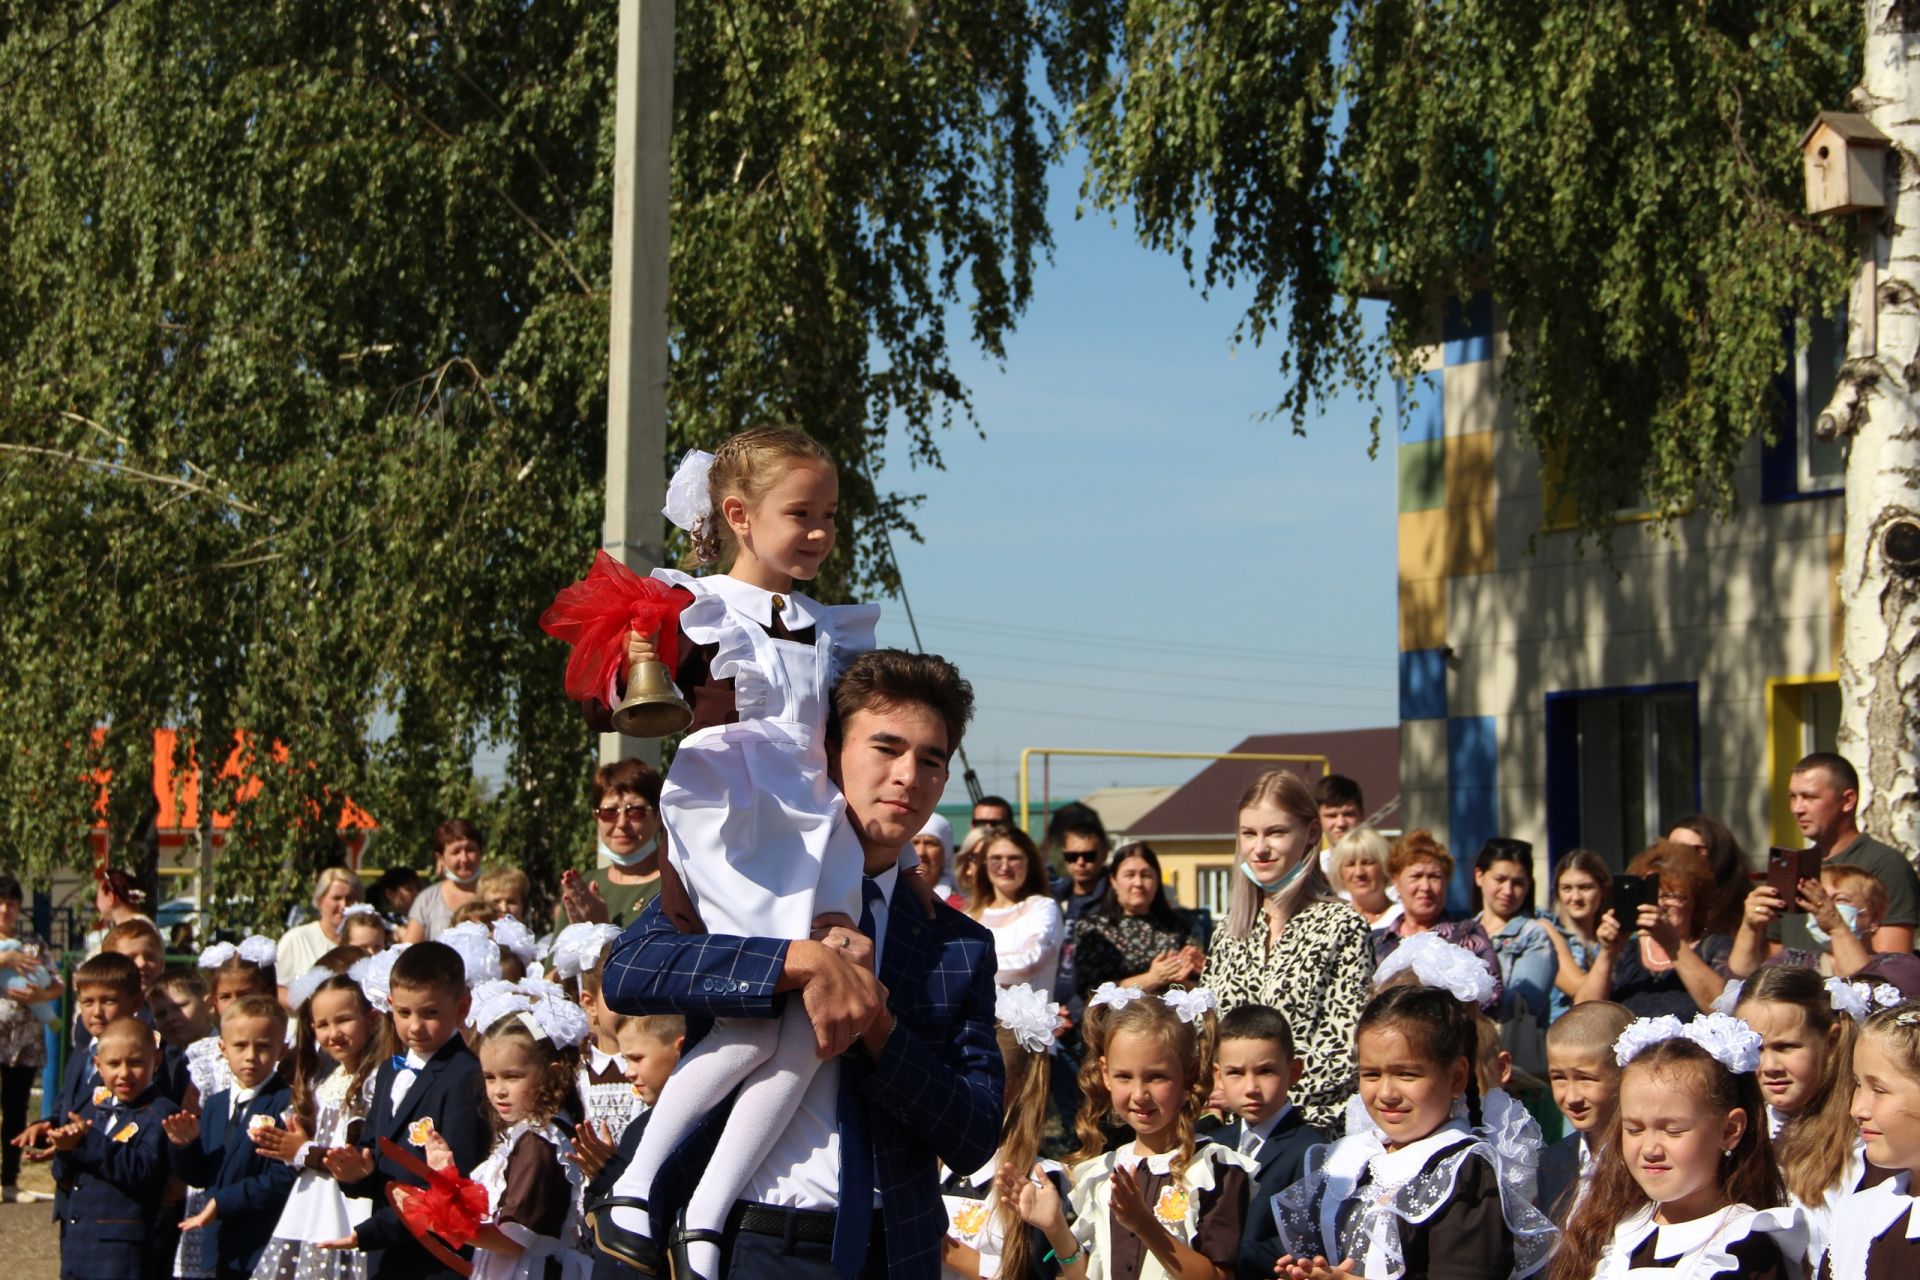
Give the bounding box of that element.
[1548,685,1699,869]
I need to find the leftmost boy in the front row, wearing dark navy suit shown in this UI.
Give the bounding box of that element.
[48,1017,179,1280]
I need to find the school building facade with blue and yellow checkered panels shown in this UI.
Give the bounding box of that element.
[1396,296,1845,898]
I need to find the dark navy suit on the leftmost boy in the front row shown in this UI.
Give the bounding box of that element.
[60,1088,180,1280]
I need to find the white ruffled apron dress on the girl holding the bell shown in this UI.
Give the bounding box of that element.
[653,568,879,938]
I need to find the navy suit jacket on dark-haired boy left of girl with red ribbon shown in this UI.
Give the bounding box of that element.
[340,1034,493,1280]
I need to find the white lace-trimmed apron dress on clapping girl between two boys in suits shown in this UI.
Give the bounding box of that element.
[253,1067,376,1280]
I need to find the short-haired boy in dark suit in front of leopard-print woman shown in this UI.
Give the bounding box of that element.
[1213,1004,1327,1276]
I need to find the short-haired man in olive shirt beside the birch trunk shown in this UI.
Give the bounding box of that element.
[1728,752,1920,977]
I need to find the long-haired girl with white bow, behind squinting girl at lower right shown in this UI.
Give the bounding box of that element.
[1720,965,1901,1274]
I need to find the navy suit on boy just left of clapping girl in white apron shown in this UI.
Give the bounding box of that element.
[167,1077,298,1276]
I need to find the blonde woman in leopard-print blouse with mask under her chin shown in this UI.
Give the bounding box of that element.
[1200,770,1373,1136]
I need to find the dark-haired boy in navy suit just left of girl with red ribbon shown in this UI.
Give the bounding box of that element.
[326,942,493,1280]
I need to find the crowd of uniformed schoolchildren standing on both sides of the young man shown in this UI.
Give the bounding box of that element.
[17,875,1920,1280]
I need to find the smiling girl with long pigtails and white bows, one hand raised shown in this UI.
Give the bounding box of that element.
[998,983,1254,1280]
